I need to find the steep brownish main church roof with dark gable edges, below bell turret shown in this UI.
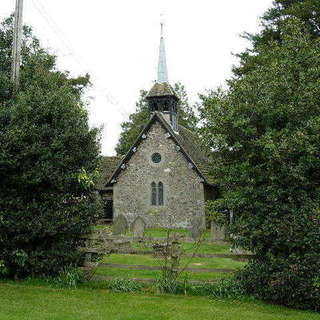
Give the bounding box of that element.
[103,112,214,186]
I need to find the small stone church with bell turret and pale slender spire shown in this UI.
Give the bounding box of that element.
[100,21,216,228]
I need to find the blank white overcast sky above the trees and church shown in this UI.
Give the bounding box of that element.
[0,0,272,155]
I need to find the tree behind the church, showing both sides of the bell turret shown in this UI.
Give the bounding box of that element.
[116,82,198,155]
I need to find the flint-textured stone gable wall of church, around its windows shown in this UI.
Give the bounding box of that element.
[113,122,204,228]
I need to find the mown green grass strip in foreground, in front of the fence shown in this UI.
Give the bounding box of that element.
[0,282,320,320]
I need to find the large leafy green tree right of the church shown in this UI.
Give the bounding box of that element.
[201,19,320,310]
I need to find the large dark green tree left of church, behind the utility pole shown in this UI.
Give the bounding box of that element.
[0,18,100,277]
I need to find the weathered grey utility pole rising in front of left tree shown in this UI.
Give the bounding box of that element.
[11,0,23,92]
